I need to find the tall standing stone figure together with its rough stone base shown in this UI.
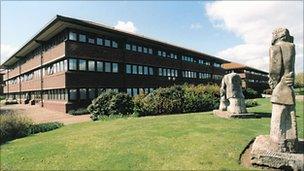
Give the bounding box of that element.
[245,28,304,170]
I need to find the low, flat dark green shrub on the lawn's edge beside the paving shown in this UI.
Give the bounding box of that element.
[29,122,63,134]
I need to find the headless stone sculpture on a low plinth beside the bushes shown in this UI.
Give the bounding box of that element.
[213,73,254,117]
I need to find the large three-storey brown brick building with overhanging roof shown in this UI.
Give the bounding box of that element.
[1,16,228,112]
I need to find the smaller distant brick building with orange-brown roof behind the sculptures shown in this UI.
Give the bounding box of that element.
[222,62,269,93]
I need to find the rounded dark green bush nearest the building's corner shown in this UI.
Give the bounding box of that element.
[87,90,134,120]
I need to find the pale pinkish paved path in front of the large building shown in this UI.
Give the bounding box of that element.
[0,104,91,125]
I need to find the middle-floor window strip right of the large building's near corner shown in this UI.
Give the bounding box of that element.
[69,58,118,73]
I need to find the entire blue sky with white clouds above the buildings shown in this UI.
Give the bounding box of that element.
[1,1,303,72]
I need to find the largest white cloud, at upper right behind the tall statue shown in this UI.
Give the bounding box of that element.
[205,1,303,72]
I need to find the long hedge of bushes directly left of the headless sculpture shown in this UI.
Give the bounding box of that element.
[134,84,220,116]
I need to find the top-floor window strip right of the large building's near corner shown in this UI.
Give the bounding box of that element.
[69,32,118,48]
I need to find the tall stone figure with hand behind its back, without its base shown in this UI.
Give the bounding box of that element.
[269,28,298,152]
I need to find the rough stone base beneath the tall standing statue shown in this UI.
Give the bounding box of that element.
[241,135,304,170]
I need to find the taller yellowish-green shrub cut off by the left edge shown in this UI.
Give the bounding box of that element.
[0,114,32,144]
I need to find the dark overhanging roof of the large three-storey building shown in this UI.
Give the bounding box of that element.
[0,15,230,68]
